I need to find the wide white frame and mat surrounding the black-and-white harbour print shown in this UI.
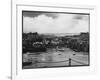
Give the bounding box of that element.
[11,0,96,80]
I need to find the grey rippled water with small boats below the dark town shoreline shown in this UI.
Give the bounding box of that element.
[23,48,88,68]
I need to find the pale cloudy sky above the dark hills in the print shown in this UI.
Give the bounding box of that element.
[23,11,89,33]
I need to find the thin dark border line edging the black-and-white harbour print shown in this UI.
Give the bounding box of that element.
[22,10,90,69]
